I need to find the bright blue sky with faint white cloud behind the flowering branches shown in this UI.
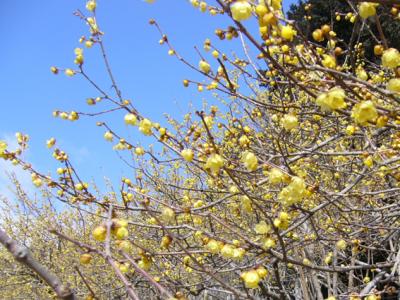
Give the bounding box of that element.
[0,0,296,202]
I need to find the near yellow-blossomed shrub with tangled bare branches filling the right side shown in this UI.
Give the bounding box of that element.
[2,0,400,299]
